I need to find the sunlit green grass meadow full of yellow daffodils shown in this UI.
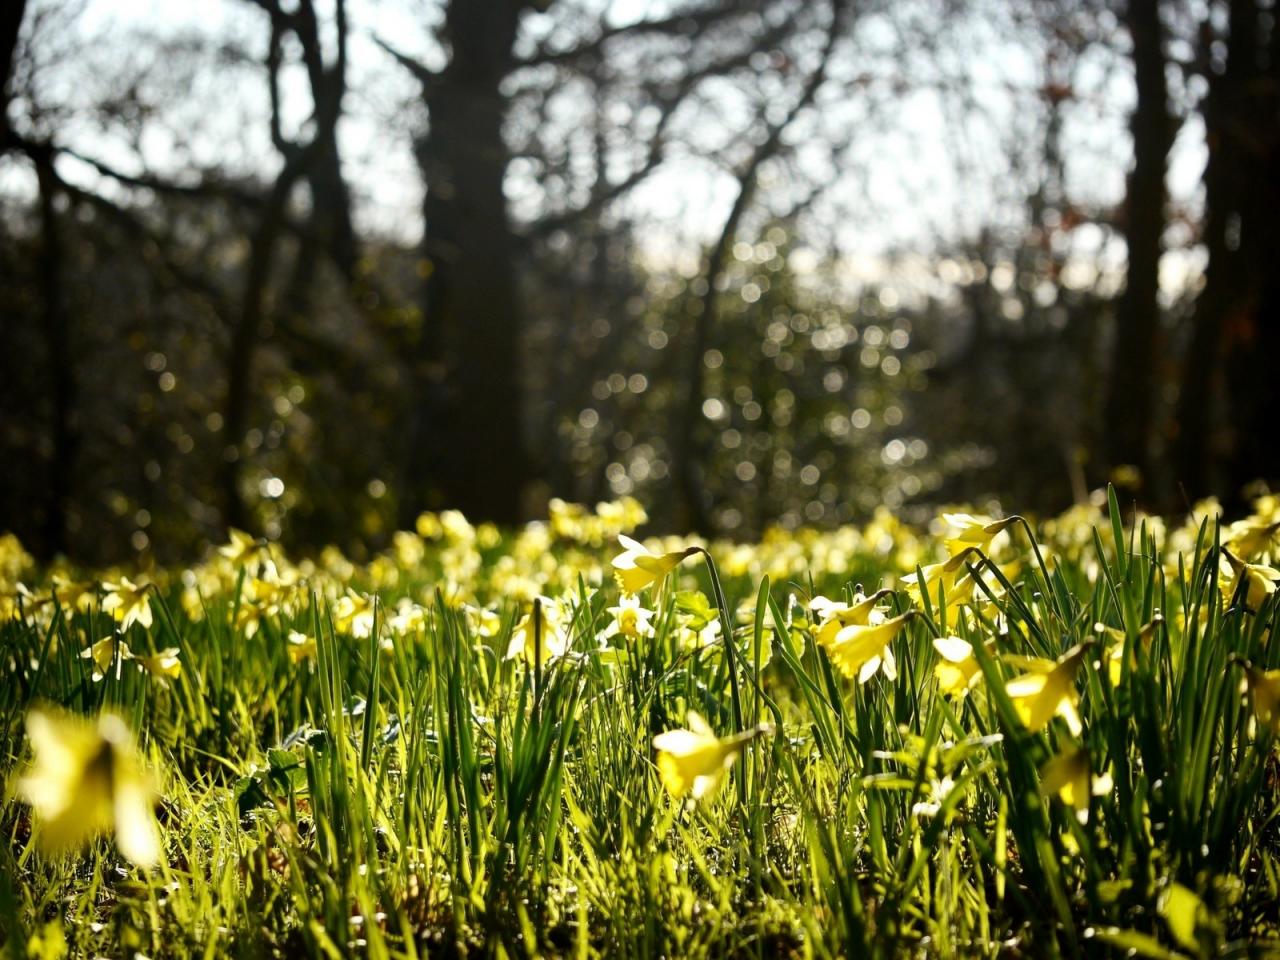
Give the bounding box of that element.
[0,492,1280,959]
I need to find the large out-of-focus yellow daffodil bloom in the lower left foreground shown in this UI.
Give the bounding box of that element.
[18,709,160,868]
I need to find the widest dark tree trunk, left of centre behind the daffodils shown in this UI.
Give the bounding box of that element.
[402,0,529,524]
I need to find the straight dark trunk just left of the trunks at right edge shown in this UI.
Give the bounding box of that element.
[1105,0,1174,506]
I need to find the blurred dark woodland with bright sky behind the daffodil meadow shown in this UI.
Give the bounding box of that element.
[0,0,1280,562]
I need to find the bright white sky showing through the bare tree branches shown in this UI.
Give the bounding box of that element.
[0,0,1204,296]
